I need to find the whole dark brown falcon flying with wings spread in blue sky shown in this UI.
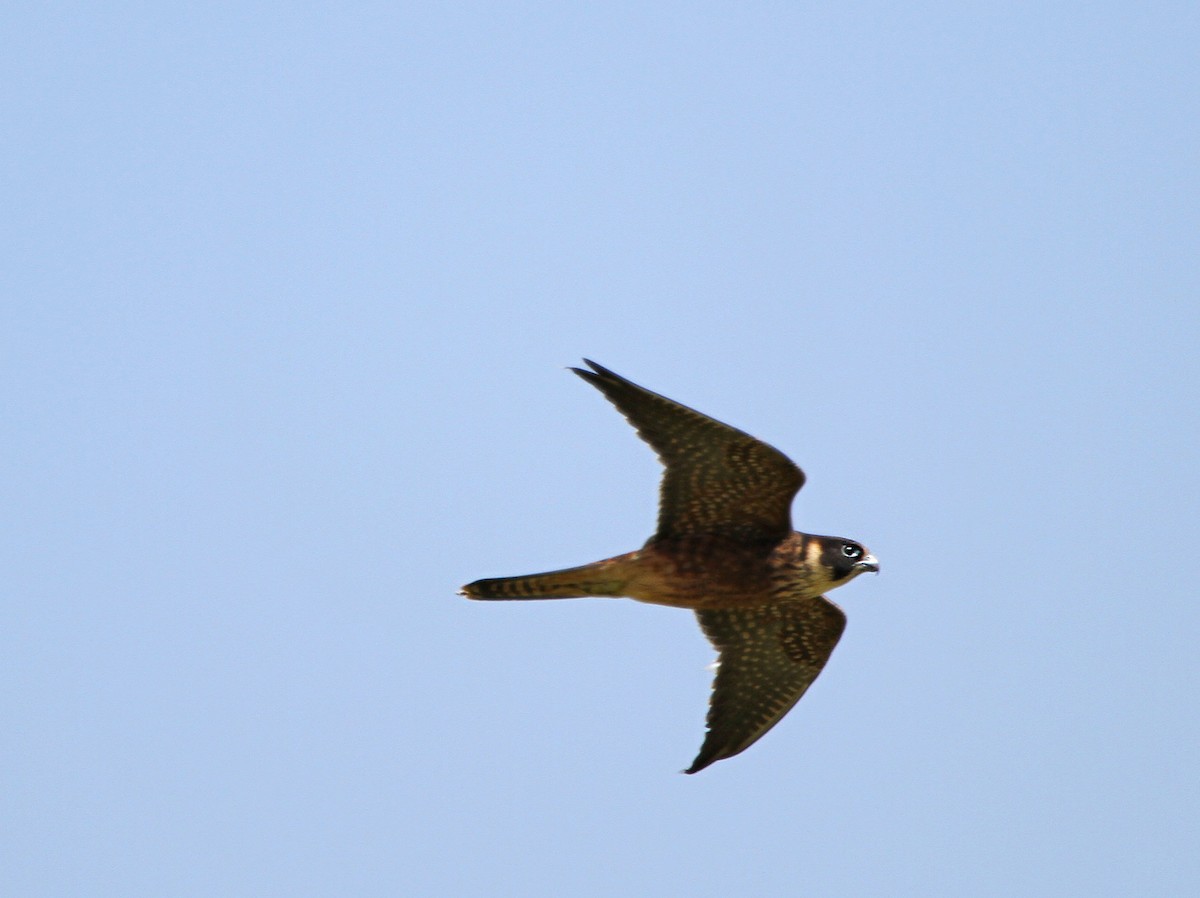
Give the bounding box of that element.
[460,359,880,773]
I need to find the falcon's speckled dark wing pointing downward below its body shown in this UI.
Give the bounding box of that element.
[686,595,846,773]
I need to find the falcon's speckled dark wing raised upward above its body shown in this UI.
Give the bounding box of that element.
[571,359,804,543]
